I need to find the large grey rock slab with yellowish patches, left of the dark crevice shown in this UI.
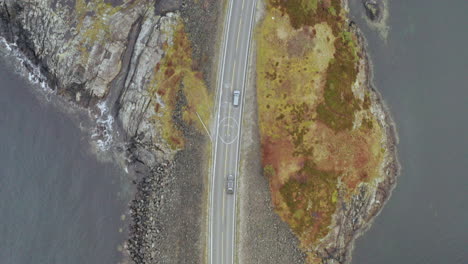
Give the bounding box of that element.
[0,0,147,99]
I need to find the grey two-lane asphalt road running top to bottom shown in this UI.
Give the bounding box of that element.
[208,0,257,264]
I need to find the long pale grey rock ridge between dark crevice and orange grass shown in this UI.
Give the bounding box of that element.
[116,13,177,162]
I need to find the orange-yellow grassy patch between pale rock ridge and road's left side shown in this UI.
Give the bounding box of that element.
[149,21,213,149]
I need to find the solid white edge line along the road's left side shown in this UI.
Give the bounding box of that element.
[208,0,234,264]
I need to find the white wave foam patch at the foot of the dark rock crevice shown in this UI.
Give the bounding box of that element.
[91,101,114,151]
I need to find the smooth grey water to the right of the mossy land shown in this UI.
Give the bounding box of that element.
[350,0,468,264]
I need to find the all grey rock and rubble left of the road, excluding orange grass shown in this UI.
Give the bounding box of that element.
[0,0,221,263]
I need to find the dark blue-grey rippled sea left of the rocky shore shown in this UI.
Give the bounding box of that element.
[0,51,128,264]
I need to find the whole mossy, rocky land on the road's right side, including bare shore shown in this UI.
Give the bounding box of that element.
[241,0,399,263]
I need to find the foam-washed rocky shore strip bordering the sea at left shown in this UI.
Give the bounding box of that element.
[0,36,128,163]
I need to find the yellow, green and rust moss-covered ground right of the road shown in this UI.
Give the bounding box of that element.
[256,0,383,260]
